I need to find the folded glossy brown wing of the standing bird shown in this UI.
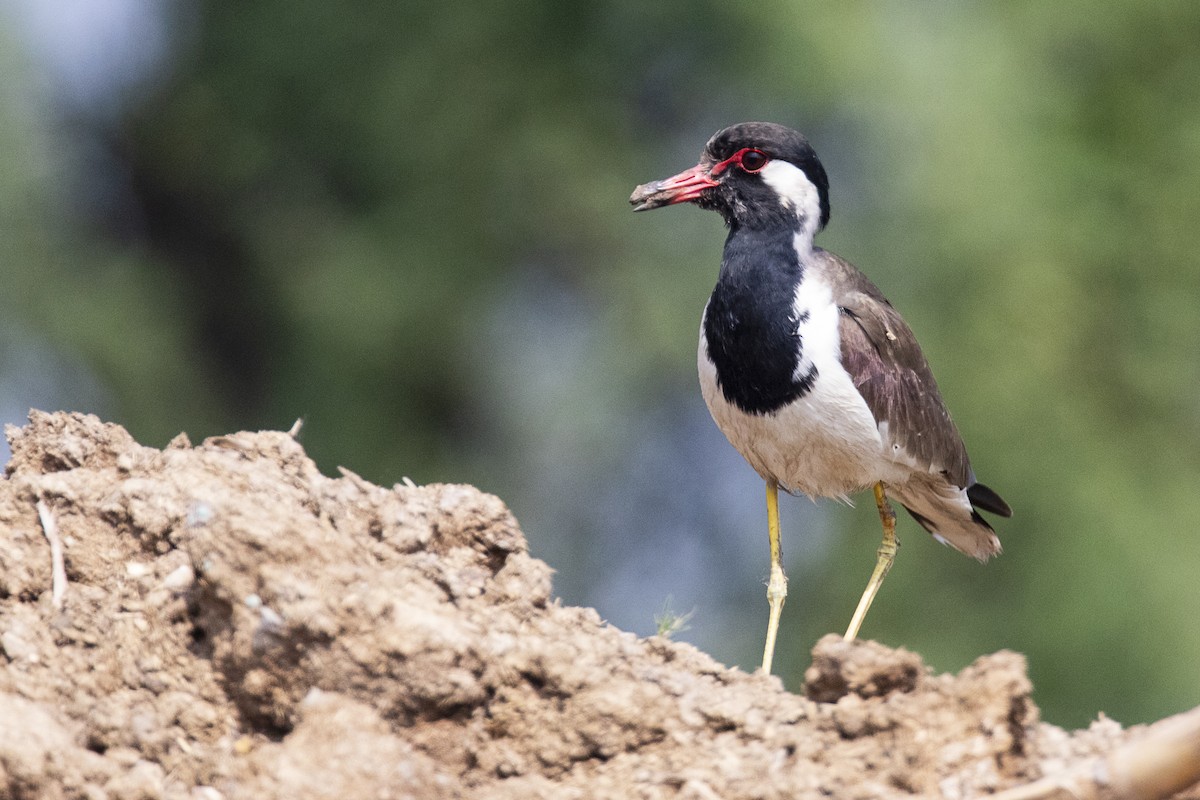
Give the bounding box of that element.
[822,251,974,488]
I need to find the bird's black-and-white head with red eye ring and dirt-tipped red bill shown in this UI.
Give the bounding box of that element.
[629,122,829,239]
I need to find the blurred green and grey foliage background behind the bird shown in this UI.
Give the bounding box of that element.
[0,0,1200,726]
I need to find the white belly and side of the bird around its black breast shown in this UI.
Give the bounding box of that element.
[697,279,899,499]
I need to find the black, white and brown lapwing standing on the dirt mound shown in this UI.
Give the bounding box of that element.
[630,122,1013,674]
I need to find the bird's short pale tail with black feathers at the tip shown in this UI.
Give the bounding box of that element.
[888,475,1013,561]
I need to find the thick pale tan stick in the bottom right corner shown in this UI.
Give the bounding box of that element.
[991,706,1200,800]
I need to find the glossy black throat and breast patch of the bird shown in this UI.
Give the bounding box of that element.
[704,227,817,414]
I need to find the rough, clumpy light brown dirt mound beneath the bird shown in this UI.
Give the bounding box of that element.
[0,413,1200,800]
